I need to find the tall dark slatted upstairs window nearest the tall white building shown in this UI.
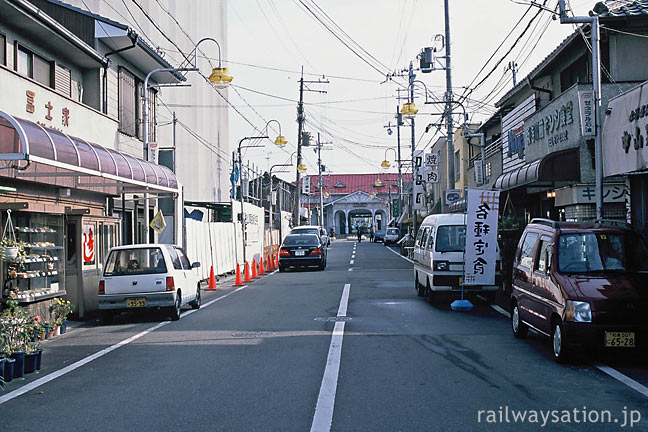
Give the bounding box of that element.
[119,68,156,141]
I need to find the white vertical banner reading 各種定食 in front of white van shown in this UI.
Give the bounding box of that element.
[464,189,499,285]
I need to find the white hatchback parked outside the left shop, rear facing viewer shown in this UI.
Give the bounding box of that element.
[98,244,201,322]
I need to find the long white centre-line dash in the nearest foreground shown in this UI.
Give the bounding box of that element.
[311,284,351,432]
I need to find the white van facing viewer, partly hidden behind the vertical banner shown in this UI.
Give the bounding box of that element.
[414,213,500,302]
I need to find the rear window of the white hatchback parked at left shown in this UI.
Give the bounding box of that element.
[104,247,167,276]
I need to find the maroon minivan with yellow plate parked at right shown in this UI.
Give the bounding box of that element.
[511,219,648,362]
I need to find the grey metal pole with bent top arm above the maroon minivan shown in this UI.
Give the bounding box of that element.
[558,0,603,219]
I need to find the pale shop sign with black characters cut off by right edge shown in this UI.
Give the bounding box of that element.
[603,83,648,176]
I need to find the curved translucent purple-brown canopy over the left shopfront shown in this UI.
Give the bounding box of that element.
[0,111,179,195]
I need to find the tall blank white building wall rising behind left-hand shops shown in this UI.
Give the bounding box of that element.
[65,0,230,202]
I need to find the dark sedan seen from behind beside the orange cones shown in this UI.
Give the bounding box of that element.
[279,234,326,272]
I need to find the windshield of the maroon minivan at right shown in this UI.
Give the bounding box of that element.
[558,233,648,273]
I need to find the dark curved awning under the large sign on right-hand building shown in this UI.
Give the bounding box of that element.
[493,148,580,190]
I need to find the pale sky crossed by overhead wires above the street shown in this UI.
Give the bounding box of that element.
[224,0,596,181]
